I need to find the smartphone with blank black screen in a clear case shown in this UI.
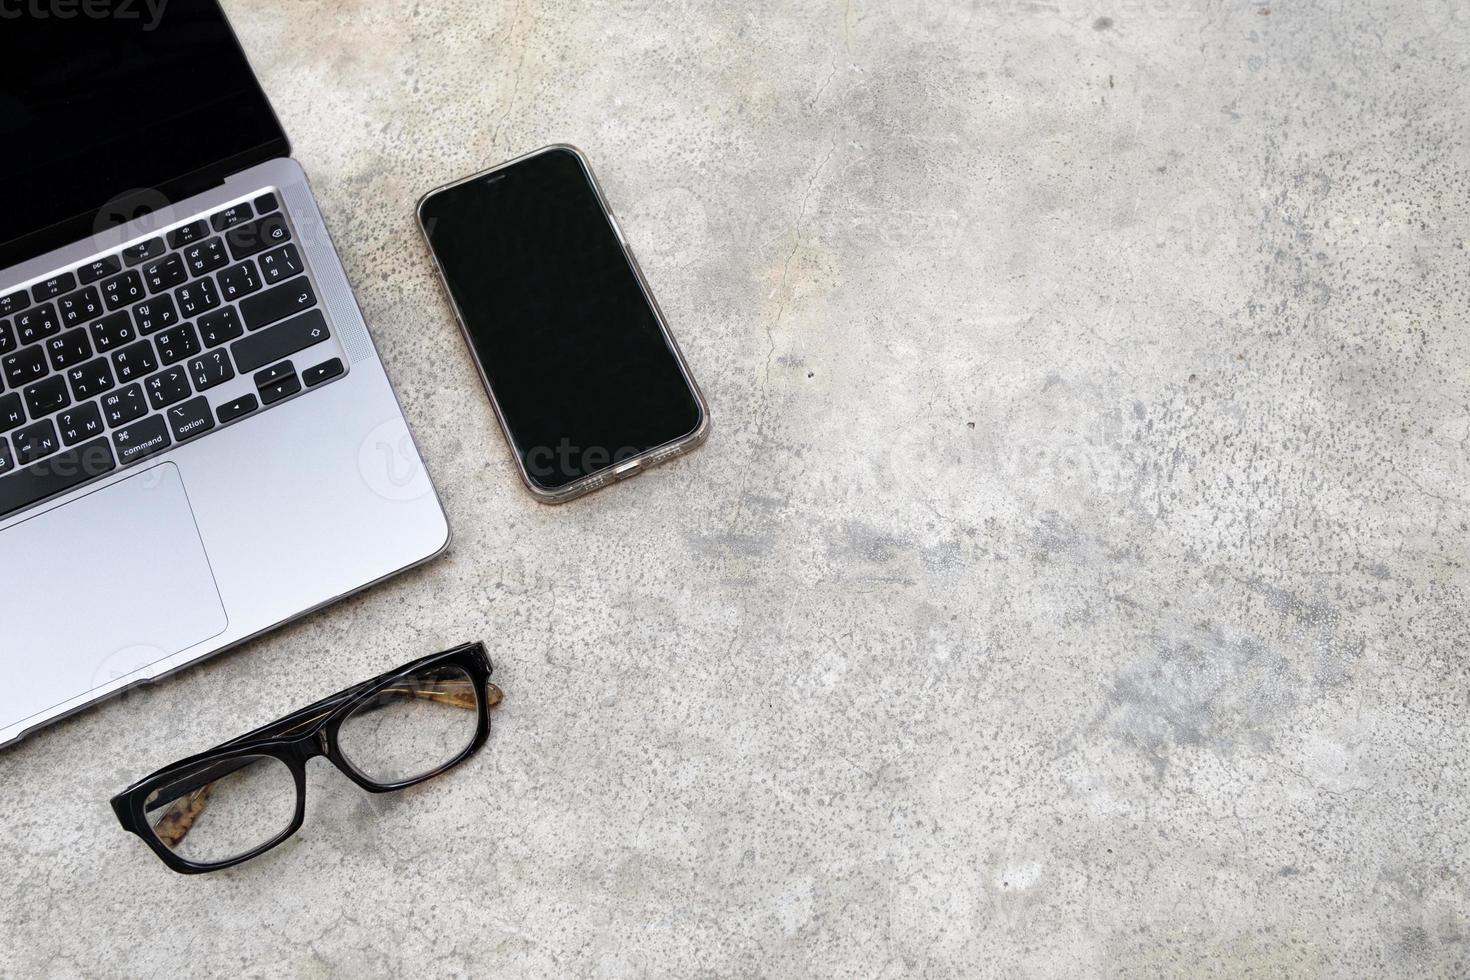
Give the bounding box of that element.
[419,145,710,504]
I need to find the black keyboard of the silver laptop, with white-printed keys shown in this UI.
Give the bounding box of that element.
[0,192,345,519]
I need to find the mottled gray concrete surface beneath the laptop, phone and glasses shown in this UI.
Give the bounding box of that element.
[0,0,1470,979]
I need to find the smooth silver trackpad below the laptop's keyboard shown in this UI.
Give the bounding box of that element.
[0,463,228,729]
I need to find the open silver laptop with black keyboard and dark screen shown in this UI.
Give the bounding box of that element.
[0,0,448,745]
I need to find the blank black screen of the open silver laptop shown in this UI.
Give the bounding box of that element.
[0,0,290,266]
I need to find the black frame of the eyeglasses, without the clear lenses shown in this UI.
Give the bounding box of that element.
[112,642,498,874]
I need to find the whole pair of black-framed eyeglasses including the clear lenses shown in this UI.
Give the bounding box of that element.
[112,644,501,874]
